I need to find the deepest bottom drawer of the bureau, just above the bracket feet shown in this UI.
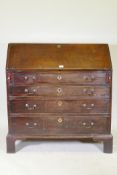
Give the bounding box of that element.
[9,116,110,135]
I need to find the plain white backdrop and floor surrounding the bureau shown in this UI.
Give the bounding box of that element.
[0,0,117,175]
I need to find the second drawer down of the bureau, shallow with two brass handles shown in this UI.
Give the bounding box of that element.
[9,84,110,98]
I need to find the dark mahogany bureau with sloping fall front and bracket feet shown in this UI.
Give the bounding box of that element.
[6,43,112,153]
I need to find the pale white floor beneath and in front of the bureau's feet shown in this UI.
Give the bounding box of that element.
[0,125,117,175]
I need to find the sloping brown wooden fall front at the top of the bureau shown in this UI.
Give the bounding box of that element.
[6,44,112,70]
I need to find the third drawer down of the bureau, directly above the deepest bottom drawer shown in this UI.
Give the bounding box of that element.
[9,98,110,114]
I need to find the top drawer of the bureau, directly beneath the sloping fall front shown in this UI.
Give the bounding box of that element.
[8,71,107,86]
